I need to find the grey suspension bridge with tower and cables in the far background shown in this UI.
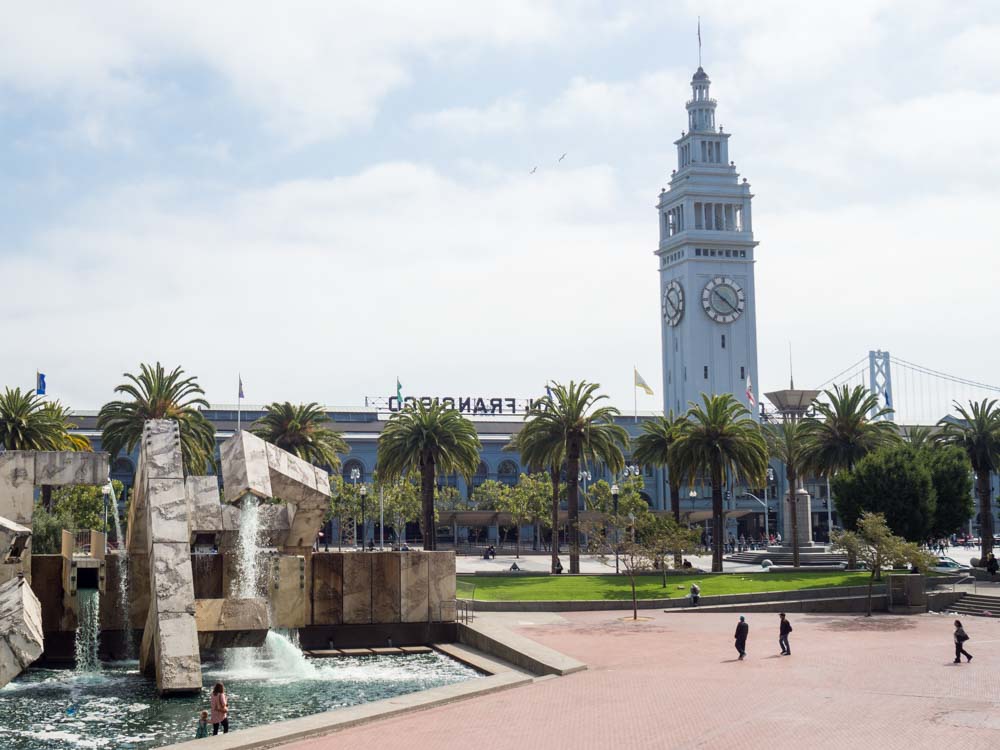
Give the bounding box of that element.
[816,350,1000,425]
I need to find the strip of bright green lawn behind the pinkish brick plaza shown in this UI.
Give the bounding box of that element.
[458,572,869,601]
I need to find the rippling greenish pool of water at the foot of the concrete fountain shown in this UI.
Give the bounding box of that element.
[0,648,479,750]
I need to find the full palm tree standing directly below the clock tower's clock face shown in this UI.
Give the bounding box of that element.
[673,393,767,573]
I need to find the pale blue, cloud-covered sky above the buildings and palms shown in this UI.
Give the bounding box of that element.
[0,0,1000,418]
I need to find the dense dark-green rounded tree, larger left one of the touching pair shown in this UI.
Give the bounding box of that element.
[833,443,937,541]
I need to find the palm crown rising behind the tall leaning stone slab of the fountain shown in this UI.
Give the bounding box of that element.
[97,362,215,474]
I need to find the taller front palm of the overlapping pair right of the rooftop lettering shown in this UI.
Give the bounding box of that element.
[524,380,628,573]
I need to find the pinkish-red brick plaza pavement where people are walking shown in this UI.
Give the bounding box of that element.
[283,612,1000,750]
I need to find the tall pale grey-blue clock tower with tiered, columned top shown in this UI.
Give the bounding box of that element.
[656,66,757,414]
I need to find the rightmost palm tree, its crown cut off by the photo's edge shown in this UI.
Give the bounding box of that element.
[937,399,1000,565]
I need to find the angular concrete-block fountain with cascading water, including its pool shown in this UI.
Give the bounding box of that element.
[0,421,464,750]
